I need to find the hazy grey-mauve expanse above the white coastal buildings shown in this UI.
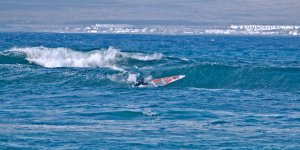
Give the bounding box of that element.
[0,0,300,28]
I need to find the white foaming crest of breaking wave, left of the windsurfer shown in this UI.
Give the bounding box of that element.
[4,46,163,71]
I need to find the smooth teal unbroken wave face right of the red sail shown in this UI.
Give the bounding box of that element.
[161,64,300,91]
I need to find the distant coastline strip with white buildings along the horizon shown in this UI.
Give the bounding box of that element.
[0,24,300,36]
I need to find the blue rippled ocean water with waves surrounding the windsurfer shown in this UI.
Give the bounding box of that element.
[0,33,300,149]
